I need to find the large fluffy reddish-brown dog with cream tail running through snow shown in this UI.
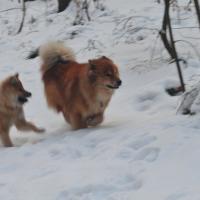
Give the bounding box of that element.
[39,42,121,129]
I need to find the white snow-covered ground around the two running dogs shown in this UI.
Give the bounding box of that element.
[0,0,200,200]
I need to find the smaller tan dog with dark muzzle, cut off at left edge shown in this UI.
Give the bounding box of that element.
[0,74,44,147]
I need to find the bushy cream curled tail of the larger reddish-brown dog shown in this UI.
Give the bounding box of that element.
[39,42,76,73]
